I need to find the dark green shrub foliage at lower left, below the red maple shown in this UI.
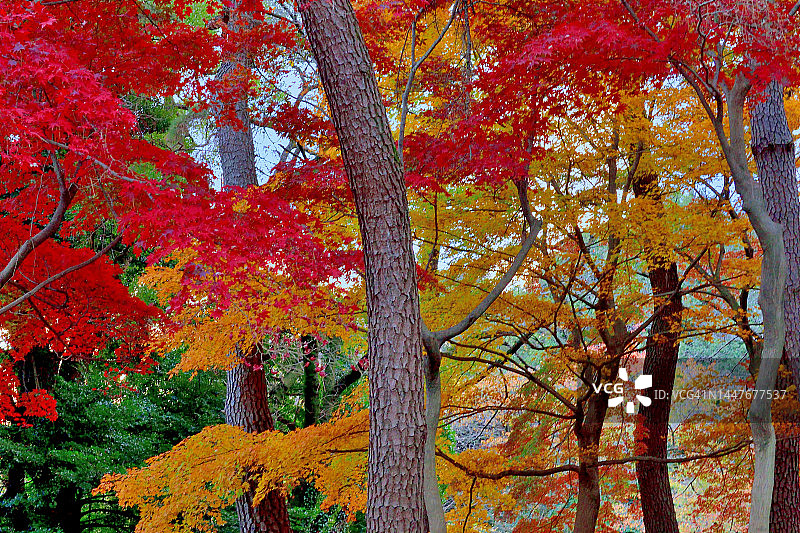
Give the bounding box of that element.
[0,354,237,533]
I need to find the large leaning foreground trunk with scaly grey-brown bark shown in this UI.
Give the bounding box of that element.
[300,0,432,533]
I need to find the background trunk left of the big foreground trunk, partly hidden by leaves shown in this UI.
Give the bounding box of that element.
[217,2,291,533]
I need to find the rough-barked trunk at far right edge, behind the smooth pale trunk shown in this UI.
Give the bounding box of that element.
[750,81,800,533]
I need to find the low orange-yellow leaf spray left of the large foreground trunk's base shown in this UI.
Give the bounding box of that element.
[95,410,368,533]
